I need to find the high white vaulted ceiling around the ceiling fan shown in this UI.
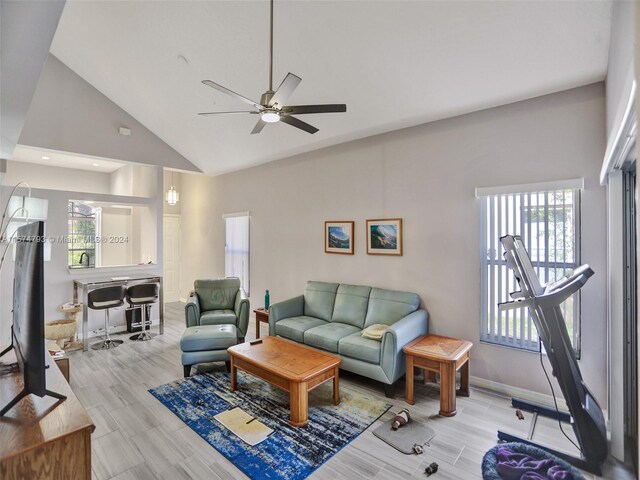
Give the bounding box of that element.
[51,0,612,174]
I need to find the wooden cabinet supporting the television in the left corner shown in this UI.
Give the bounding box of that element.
[0,354,95,480]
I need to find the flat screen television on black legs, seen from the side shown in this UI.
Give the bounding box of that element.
[0,222,65,417]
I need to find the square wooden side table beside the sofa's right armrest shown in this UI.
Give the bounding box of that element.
[402,335,473,417]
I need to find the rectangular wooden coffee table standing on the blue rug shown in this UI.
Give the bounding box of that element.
[228,337,341,427]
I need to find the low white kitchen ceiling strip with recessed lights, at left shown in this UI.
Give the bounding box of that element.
[12,145,126,173]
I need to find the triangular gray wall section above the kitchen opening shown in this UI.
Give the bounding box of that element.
[20,54,200,172]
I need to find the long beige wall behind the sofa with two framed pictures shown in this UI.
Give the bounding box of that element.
[181,83,607,408]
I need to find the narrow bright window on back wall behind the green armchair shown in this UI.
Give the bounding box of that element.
[223,213,249,296]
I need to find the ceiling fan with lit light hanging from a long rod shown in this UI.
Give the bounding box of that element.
[198,0,347,134]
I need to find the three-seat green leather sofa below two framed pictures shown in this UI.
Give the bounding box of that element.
[269,281,428,397]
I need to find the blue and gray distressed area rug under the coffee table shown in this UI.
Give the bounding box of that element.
[149,371,391,480]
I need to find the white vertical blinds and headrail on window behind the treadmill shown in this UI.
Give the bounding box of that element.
[476,179,584,356]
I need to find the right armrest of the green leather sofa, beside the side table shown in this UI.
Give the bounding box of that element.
[380,309,429,383]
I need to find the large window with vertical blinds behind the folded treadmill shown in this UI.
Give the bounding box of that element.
[477,186,580,354]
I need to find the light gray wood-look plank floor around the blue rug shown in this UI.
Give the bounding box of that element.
[70,303,634,480]
